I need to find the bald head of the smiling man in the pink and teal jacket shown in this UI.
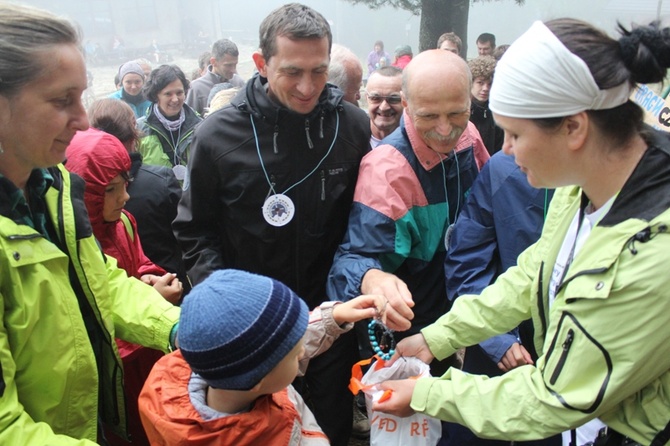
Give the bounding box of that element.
[402,49,472,154]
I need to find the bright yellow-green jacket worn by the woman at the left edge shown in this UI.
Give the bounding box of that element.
[0,165,179,445]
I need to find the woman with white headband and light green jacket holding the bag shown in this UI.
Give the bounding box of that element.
[373,19,670,446]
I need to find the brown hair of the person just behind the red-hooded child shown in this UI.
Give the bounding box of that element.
[88,98,140,149]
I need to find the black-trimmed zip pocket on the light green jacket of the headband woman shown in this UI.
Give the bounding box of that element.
[543,312,612,413]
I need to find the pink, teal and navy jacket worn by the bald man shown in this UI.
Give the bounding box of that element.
[327,110,489,335]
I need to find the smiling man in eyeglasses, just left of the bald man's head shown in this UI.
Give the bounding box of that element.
[365,67,402,149]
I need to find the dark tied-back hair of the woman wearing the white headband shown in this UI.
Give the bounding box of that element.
[546,18,670,142]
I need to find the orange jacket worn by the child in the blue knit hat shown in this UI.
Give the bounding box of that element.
[139,351,329,446]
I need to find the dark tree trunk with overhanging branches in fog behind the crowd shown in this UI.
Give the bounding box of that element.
[347,0,524,54]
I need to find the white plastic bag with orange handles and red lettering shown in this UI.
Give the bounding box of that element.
[350,358,442,446]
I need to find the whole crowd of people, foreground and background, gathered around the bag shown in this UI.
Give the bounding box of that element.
[0,3,670,446]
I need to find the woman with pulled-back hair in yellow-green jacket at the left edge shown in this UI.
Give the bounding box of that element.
[0,4,179,445]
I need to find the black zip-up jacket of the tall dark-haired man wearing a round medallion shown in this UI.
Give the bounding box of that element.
[173,74,370,308]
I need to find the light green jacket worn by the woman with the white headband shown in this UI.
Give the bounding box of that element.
[411,127,670,445]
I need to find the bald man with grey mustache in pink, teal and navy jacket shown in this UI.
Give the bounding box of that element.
[327,49,489,376]
